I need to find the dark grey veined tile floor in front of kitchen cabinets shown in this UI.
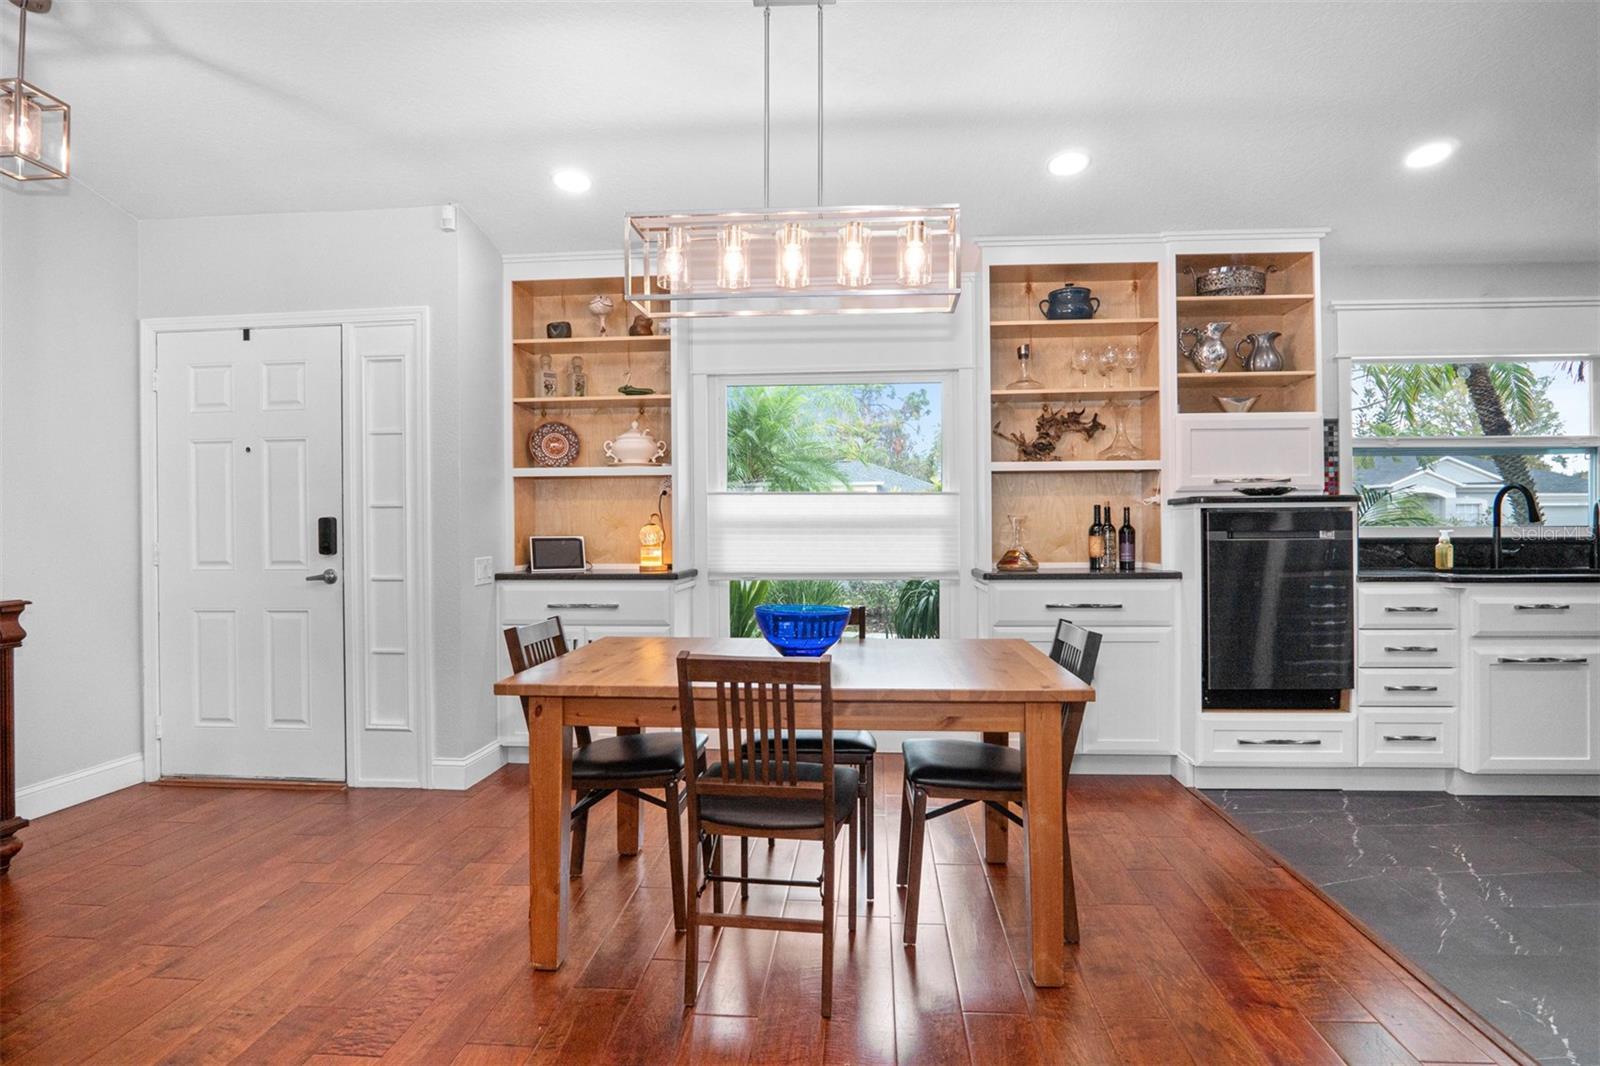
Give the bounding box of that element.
[1206,789,1600,1066]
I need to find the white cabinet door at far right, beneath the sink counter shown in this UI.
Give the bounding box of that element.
[1461,640,1600,773]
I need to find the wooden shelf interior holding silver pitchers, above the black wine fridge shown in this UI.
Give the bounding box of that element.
[1178,251,1318,415]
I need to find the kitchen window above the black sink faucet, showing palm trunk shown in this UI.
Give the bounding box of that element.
[1350,357,1600,528]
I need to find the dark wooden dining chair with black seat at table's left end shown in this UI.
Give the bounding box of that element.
[506,618,706,932]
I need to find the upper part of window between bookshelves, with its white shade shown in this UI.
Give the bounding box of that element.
[706,375,960,579]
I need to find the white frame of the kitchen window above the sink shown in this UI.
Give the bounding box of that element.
[1338,352,1600,539]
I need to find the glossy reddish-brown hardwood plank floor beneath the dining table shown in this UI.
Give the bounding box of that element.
[0,759,1515,1066]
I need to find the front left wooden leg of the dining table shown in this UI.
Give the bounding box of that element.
[523,696,573,970]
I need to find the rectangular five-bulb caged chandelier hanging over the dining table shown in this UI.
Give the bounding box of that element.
[622,0,962,319]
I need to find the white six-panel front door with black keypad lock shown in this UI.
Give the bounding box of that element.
[155,327,346,781]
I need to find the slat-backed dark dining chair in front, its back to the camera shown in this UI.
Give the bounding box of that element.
[678,651,861,1018]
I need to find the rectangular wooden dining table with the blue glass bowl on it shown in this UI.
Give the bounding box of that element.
[494,637,1094,988]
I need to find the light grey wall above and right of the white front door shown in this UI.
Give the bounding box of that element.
[139,206,506,762]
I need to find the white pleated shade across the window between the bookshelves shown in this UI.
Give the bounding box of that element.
[706,493,960,578]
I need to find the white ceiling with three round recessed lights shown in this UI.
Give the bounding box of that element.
[12,0,1600,262]
